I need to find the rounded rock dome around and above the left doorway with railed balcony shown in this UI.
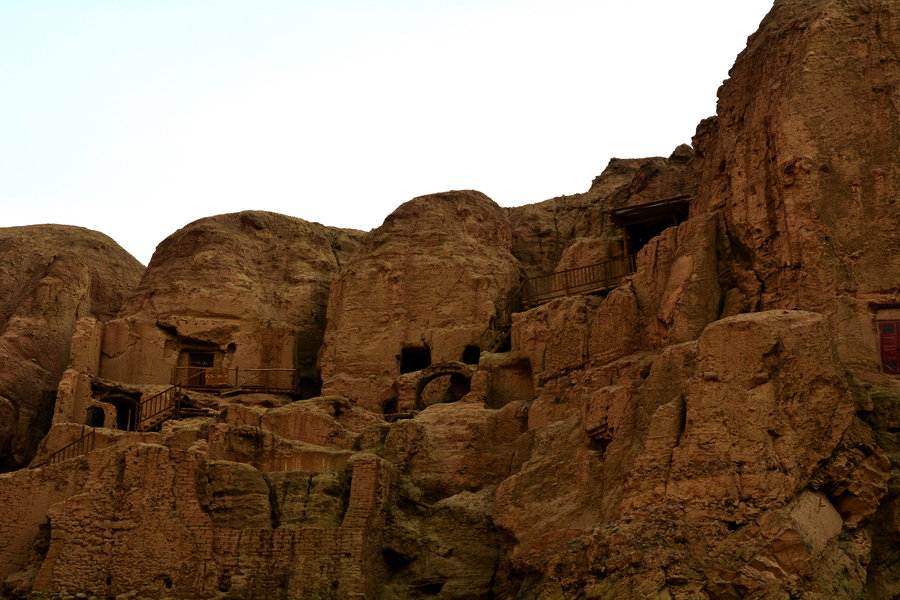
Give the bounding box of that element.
[101,211,361,395]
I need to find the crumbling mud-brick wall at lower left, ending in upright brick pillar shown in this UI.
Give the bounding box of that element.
[0,444,389,600]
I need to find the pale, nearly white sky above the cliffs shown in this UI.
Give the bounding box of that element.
[0,0,772,264]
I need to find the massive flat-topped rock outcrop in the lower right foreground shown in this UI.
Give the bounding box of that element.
[494,311,890,597]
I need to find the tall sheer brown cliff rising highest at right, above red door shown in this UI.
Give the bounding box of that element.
[692,0,900,370]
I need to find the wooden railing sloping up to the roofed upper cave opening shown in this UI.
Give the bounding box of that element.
[522,256,635,307]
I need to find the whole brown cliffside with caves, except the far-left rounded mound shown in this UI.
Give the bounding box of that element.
[0,0,900,600]
